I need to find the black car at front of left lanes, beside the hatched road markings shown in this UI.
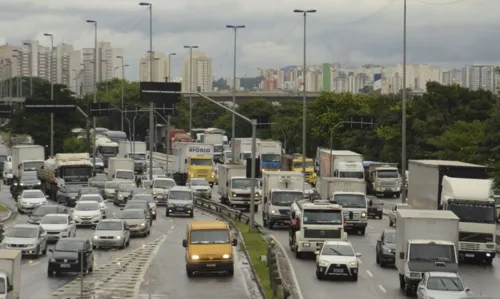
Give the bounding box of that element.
[47,238,94,277]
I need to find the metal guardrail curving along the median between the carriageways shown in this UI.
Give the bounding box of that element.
[194,197,302,299]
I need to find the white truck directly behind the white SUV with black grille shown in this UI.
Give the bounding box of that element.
[288,199,347,258]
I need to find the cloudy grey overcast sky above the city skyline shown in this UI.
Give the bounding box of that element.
[0,0,500,79]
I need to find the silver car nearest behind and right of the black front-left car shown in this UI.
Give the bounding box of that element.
[92,219,130,249]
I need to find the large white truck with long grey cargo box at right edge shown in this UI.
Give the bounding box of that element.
[408,160,497,264]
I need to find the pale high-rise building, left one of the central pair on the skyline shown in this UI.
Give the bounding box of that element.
[139,51,169,82]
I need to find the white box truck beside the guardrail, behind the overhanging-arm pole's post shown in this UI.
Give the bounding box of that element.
[218,164,262,212]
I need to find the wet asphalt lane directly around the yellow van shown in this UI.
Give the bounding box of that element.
[140,210,249,299]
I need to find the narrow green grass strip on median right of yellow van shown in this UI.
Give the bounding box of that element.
[235,221,281,299]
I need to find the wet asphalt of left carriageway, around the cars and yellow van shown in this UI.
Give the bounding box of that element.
[0,185,259,299]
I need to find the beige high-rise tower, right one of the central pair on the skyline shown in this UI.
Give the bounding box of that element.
[182,51,213,92]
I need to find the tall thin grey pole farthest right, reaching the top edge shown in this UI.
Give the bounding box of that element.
[401,0,407,203]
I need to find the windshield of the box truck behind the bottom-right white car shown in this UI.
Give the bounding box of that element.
[410,244,455,263]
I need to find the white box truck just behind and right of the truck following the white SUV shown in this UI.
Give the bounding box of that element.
[320,177,368,235]
